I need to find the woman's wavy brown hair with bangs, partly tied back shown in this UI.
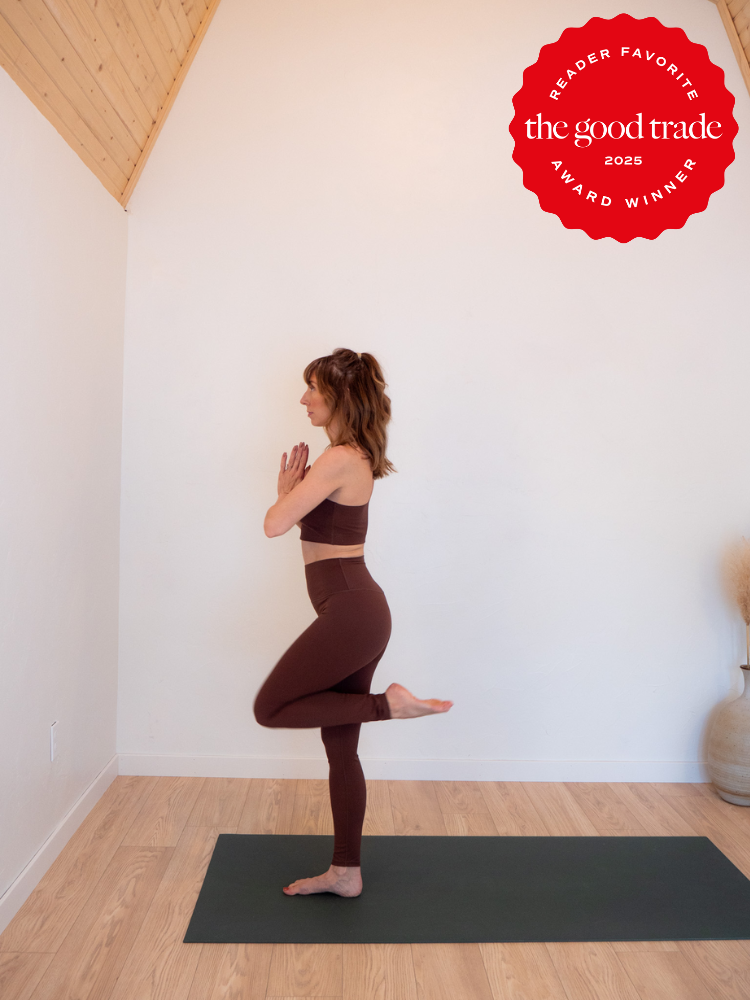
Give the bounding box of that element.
[304,347,396,479]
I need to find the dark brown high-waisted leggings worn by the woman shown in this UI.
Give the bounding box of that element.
[255,556,391,868]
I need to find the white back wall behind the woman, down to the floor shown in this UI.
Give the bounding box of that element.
[118,0,750,780]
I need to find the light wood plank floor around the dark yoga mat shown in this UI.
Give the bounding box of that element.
[0,777,750,1000]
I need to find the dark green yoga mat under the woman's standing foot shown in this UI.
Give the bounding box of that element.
[185,833,750,944]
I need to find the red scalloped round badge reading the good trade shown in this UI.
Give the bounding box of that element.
[510,14,737,243]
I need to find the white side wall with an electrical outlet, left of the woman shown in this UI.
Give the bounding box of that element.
[0,72,127,908]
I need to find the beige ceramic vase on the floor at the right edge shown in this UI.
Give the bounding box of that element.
[708,666,750,806]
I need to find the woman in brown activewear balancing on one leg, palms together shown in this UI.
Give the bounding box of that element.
[255,348,452,896]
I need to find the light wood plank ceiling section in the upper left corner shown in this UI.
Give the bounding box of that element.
[0,0,219,205]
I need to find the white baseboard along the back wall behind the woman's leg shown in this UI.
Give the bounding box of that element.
[120,753,709,781]
